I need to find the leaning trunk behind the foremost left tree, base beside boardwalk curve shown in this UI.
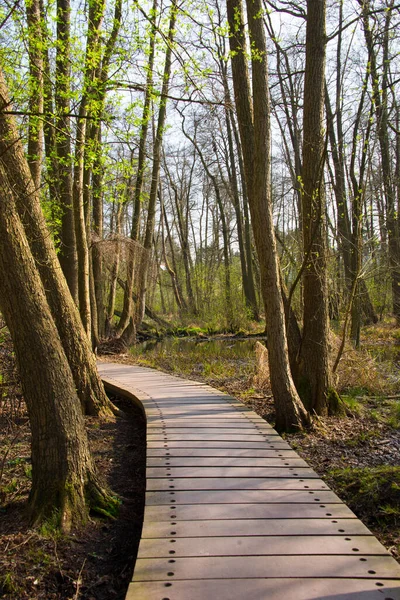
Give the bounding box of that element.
[0,72,114,414]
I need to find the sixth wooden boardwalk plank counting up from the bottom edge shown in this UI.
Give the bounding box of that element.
[146,490,342,506]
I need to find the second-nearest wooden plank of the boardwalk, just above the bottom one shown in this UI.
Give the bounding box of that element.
[135,555,400,581]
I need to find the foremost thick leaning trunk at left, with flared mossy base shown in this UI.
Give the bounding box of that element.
[0,164,115,530]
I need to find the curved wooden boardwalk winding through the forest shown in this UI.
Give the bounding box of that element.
[99,363,400,600]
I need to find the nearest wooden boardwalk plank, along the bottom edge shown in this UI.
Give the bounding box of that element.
[126,571,400,600]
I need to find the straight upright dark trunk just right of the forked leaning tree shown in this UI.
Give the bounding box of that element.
[298,0,336,415]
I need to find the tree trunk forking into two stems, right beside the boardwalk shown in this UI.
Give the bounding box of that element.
[227,0,309,430]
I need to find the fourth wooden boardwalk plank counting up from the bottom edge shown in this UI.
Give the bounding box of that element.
[142,515,372,547]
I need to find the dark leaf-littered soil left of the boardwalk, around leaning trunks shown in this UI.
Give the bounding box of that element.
[0,398,145,600]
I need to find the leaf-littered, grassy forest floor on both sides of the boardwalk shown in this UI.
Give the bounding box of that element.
[0,324,400,600]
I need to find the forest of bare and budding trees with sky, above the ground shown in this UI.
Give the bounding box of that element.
[0,0,400,596]
